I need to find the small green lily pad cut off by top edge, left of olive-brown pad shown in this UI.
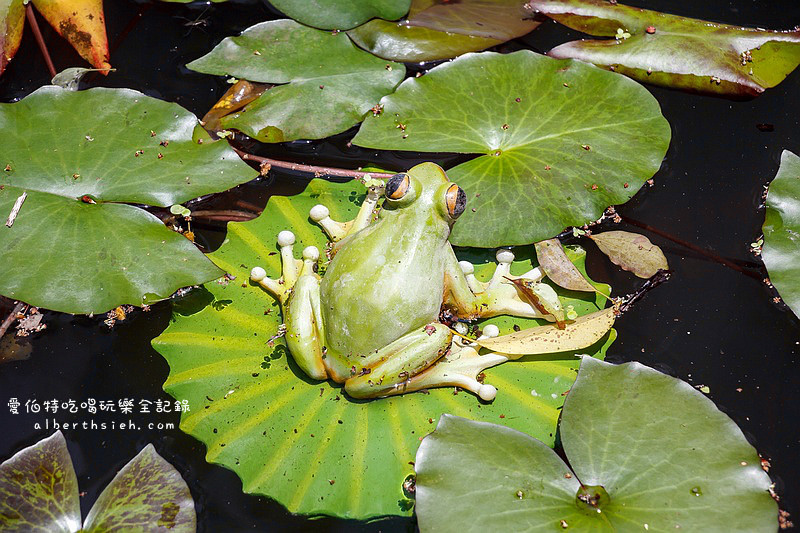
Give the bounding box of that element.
[270,0,411,30]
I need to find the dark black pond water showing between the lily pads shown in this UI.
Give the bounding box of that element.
[0,0,800,531]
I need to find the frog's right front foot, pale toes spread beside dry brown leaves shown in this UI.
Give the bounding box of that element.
[458,248,552,319]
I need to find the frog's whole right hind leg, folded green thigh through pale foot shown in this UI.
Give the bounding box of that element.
[345,322,508,401]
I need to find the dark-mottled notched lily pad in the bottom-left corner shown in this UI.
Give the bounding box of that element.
[0,431,197,533]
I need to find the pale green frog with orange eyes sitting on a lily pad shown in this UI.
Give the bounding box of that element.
[250,163,557,401]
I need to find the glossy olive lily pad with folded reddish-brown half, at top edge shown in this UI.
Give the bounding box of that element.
[348,0,540,62]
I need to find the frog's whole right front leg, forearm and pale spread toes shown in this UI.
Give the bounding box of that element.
[445,249,555,320]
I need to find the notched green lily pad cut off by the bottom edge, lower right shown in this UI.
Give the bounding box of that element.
[416,357,778,532]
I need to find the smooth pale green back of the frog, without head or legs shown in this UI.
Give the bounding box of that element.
[320,216,449,361]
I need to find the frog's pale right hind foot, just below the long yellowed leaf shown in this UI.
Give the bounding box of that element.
[392,324,508,402]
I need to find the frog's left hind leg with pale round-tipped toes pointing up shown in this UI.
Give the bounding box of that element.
[250,231,328,380]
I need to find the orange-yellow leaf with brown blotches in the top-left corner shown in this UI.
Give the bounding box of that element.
[31,0,111,75]
